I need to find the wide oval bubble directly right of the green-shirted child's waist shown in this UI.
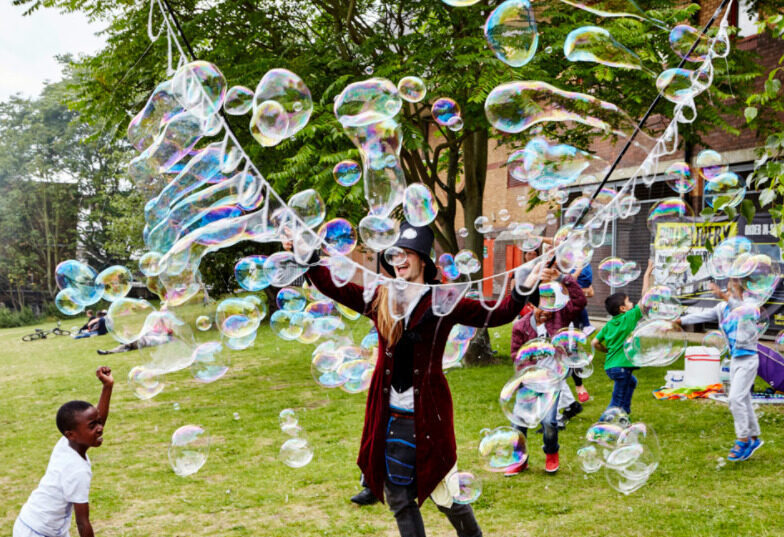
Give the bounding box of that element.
[623,318,687,367]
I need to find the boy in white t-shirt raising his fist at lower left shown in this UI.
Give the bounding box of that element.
[13,367,114,537]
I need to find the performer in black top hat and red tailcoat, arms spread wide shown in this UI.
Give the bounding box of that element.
[283,223,536,537]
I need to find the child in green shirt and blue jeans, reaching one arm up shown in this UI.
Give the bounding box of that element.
[592,260,653,414]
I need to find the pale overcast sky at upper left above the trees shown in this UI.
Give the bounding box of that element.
[0,0,103,100]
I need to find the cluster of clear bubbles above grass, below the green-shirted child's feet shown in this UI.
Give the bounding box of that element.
[577,407,661,495]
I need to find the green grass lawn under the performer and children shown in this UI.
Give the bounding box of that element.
[0,321,784,537]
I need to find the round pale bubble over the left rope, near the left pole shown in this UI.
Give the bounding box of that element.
[172,60,226,119]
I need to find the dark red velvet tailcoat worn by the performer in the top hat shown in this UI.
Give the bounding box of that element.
[307,265,525,505]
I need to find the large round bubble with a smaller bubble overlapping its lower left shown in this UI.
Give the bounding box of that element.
[253,69,313,138]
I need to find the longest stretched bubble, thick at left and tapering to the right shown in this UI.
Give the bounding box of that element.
[485,81,634,133]
